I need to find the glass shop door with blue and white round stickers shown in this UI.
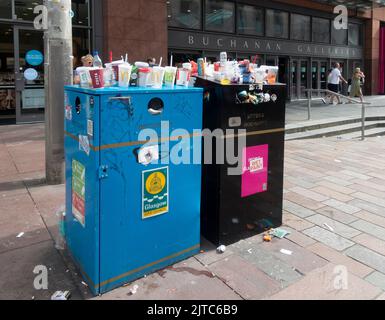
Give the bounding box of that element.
[14,26,45,123]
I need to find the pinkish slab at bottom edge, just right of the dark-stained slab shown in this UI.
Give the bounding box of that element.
[209,255,281,300]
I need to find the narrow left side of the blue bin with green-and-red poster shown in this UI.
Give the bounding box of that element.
[65,91,100,294]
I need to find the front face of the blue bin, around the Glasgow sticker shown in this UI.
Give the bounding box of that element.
[100,92,202,292]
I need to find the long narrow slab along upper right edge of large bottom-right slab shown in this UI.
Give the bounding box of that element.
[307,242,374,278]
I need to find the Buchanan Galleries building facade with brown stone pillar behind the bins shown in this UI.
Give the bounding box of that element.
[100,0,385,100]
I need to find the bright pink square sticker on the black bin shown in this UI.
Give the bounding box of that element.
[242,144,269,198]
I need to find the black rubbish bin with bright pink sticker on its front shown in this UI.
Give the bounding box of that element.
[195,77,287,245]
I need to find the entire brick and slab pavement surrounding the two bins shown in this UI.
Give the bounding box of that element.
[0,125,385,300]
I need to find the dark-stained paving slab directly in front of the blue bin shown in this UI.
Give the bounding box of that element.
[95,258,242,301]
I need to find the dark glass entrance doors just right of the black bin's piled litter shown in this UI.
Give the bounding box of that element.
[290,59,309,100]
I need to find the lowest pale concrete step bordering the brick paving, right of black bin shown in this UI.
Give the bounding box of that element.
[286,120,385,141]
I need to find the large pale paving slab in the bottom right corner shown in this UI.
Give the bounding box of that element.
[269,264,381,300]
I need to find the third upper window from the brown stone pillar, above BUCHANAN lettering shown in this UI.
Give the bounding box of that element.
[237,4,264,36]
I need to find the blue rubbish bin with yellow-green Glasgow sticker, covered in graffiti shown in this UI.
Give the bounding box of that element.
[65,86,203,294]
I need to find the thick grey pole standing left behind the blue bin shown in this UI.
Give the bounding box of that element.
[44,0,73,184]
